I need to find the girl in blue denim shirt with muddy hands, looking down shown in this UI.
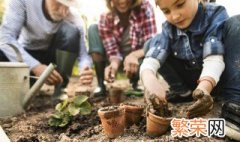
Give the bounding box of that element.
[140,0,240,118]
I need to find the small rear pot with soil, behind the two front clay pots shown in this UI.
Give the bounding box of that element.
[108,83,124,105]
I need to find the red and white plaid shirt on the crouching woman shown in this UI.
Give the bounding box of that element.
[98,0,157,57]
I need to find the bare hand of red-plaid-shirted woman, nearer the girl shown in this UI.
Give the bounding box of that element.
[123,53,139,78]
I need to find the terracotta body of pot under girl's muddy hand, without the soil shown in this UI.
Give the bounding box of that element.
[147,112,172,138]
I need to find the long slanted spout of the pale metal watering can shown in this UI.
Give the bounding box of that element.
[22,63,55,109]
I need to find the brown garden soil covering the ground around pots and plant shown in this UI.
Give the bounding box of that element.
[0,78,232,142]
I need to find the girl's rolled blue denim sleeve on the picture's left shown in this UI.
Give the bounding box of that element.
[145,30,169,64]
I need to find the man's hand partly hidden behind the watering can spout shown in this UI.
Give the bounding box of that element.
[32,64,63,85]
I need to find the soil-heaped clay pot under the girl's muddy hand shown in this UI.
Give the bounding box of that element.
[146,96,172,138]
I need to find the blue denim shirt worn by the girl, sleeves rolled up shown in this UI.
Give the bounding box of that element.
[145,4,229,65]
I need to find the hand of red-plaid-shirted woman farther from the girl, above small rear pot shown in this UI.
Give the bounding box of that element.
[104,59,121,83]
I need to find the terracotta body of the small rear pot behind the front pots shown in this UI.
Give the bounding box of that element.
[108,88,124,105]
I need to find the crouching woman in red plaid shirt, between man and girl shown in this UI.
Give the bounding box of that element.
[89,0,157,96]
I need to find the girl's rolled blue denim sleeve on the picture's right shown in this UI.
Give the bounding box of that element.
[203,6,228,58]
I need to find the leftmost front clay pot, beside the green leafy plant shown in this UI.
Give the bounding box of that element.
[98,106,125,138]
